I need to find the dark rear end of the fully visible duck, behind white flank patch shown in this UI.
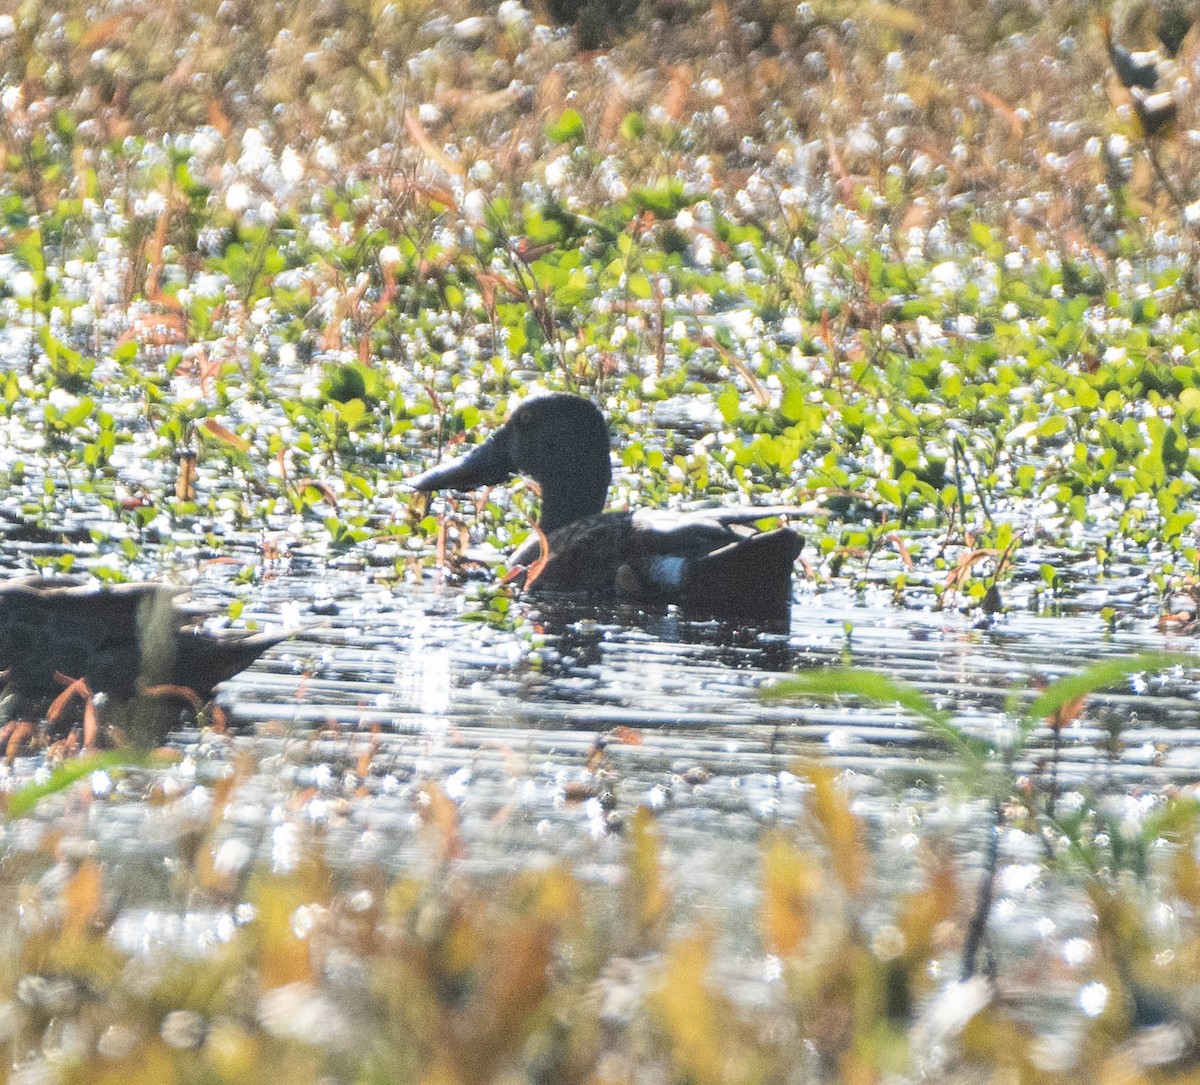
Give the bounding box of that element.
[684,528,804,621]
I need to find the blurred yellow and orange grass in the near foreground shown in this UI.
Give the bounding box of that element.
[0,762,1200,1085]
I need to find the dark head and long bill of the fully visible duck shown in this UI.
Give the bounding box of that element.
[409,395,612,532]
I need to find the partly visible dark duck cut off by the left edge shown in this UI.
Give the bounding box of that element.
[0,576,294,705]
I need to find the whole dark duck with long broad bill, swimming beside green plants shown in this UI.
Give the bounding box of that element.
[408,392,804,622]
